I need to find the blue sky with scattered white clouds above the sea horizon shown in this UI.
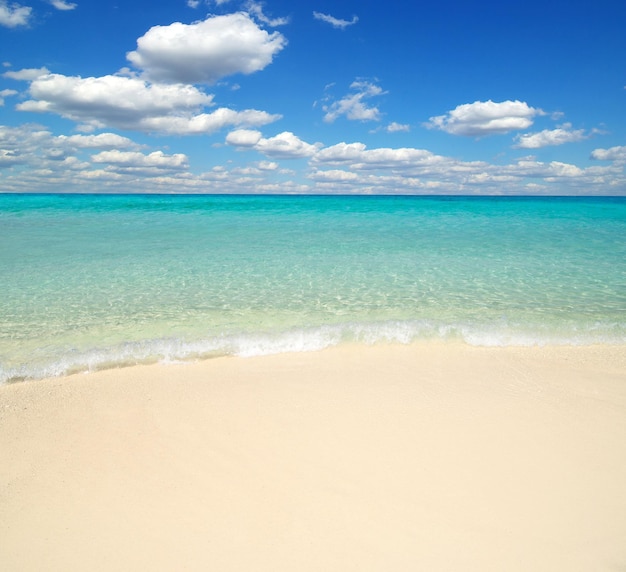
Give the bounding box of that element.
[0,0,626,195]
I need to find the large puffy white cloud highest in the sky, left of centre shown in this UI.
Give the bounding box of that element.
[126,12,287,83]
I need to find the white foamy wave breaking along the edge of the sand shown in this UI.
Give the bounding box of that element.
[0,320,626,383]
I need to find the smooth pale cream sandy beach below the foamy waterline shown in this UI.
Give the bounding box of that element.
[0,343,626,572]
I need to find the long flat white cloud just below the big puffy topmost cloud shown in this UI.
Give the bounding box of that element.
[17,74,279,135]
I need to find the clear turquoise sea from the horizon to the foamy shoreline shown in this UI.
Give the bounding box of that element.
[0,194,626,382]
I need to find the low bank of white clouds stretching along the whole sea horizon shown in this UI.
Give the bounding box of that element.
[0,125,626,194]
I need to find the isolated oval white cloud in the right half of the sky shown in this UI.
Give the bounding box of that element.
[425,100,544,137]
